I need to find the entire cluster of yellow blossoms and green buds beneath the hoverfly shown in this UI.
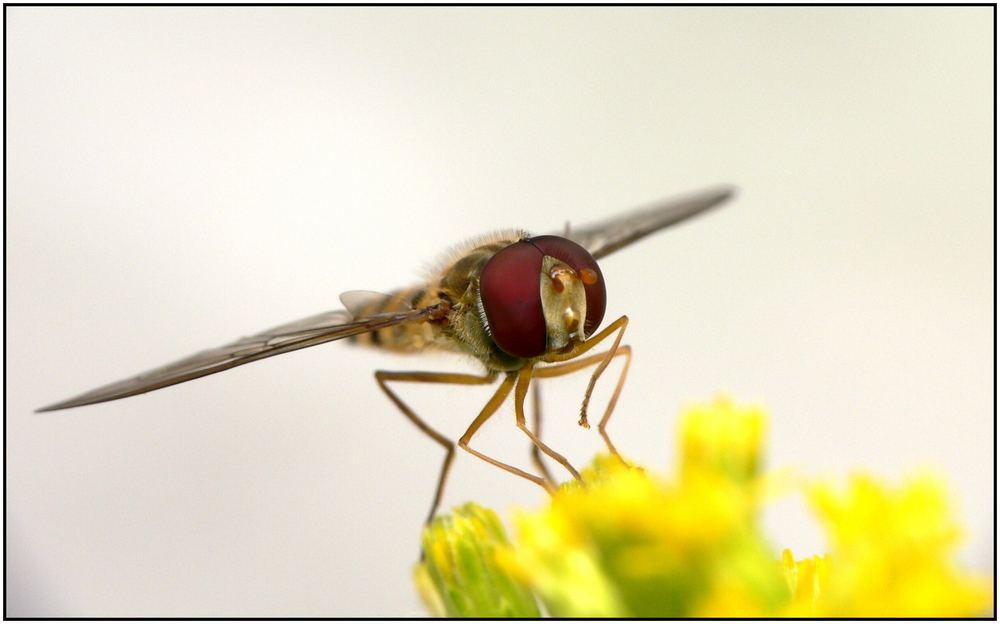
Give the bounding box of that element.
[417,397,992,617]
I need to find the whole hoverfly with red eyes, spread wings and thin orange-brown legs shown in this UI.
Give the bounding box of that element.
[38,187,732,521]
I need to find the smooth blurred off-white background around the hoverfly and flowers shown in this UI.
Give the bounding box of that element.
[5,7,995,617]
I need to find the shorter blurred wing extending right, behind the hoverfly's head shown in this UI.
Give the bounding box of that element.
[553,186,735,259]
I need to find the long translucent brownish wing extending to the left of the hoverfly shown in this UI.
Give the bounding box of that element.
[38,305,440,412]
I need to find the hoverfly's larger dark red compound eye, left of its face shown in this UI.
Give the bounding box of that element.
[479,241,545,358]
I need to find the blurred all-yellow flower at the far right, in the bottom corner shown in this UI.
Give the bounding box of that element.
[786,475,992,617]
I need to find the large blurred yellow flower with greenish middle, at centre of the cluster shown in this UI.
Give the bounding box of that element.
[501,450,787,617]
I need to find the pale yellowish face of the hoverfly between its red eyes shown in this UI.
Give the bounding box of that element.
[540,256,587,351]
